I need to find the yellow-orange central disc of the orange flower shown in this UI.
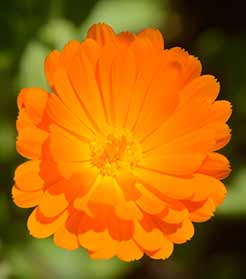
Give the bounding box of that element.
[90,128,142,176]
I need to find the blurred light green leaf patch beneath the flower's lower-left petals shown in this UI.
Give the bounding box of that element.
[4,239,131,279]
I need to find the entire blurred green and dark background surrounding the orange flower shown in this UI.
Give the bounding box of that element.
[0,0,246,279]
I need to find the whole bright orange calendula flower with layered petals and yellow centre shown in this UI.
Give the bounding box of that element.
[12,24,231,261]
